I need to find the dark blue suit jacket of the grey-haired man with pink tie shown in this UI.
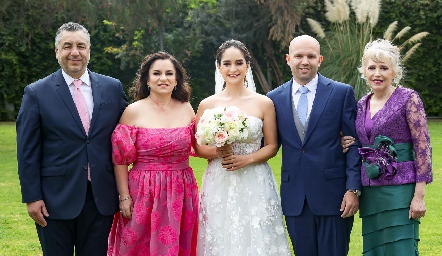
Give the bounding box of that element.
[16,69,127,219]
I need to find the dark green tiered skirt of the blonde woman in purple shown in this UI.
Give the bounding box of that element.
[359,183,420,256]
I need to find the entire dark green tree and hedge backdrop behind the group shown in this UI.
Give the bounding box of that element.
[0,0,442,120]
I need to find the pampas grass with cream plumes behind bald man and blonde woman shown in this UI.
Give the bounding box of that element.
[307,0,428,99]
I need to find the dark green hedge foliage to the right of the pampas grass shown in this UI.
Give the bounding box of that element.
[378,0,442,117]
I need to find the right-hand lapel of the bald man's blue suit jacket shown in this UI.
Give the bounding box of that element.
[304,75,333,144]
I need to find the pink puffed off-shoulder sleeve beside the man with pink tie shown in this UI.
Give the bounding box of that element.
[111,124,138,165]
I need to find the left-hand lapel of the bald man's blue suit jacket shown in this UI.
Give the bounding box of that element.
[278,78,302,144]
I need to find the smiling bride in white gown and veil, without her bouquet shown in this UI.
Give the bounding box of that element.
[195,40,291,256]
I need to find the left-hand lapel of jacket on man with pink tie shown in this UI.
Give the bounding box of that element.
[54,69,86,135]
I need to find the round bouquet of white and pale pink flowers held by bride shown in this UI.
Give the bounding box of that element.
[195,106,250,147]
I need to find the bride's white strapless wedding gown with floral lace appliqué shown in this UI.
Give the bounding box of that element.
[197,117,292,256]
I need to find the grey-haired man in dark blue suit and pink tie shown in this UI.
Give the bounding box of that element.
[16,22,127,256]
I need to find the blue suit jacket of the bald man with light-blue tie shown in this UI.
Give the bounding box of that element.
[267,74,361,216]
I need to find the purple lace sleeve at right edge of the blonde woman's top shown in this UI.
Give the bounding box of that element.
[406,92,433,183]
